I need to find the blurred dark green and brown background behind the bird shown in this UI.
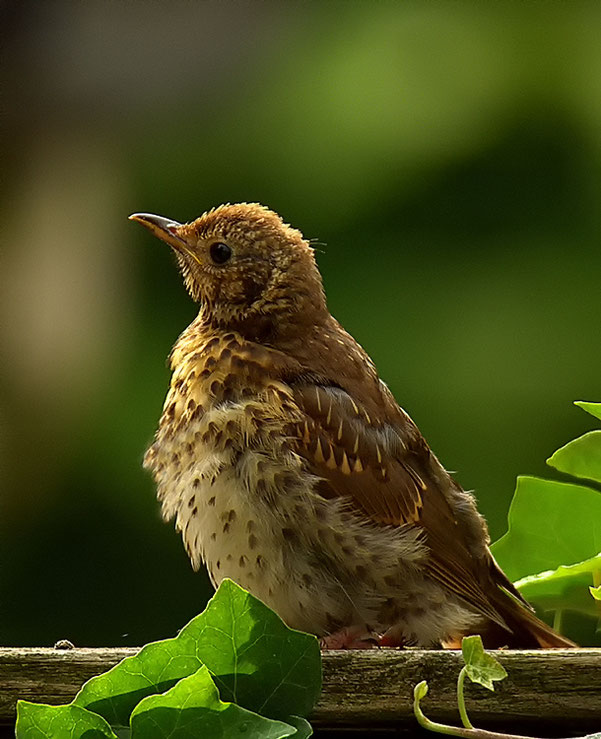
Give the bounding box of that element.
[0,0,601,646]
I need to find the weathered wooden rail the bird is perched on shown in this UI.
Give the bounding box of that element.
[0,648,601,737]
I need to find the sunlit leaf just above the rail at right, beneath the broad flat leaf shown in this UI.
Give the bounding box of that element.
[515,554,601,617]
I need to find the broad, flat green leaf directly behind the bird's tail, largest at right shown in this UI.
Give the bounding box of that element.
[492,477,601,580]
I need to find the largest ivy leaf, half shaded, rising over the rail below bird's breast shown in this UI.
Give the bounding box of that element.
[74,580,321,726]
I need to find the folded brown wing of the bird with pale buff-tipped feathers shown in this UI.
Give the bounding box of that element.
[294,384,507,628]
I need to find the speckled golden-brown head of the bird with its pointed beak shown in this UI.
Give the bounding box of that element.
[130,203,326,340]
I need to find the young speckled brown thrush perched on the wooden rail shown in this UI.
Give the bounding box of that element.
[130,203,573,649]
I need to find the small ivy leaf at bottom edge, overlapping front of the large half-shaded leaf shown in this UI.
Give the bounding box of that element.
[131,667,296,739]
